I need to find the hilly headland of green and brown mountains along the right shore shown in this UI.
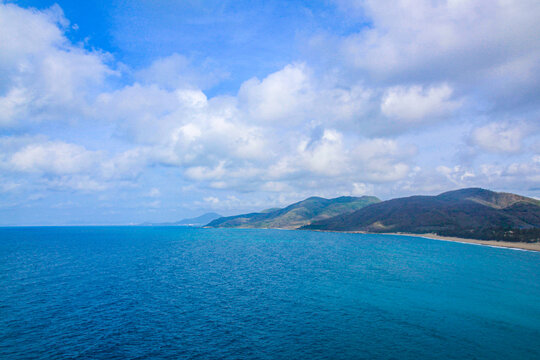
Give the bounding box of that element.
[206,188,540,249]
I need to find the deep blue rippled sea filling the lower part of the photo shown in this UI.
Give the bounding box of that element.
[0,227,540,359]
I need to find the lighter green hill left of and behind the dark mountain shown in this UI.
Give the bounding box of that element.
[207,196,380,229]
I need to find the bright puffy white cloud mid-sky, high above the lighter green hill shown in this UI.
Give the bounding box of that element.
[238,63,374,127]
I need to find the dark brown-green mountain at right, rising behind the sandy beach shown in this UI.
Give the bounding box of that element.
[302,188,540,242]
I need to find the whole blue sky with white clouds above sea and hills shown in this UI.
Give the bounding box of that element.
[0,0,540,225]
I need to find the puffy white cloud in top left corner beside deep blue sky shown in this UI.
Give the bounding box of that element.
[0,3,114,127]
